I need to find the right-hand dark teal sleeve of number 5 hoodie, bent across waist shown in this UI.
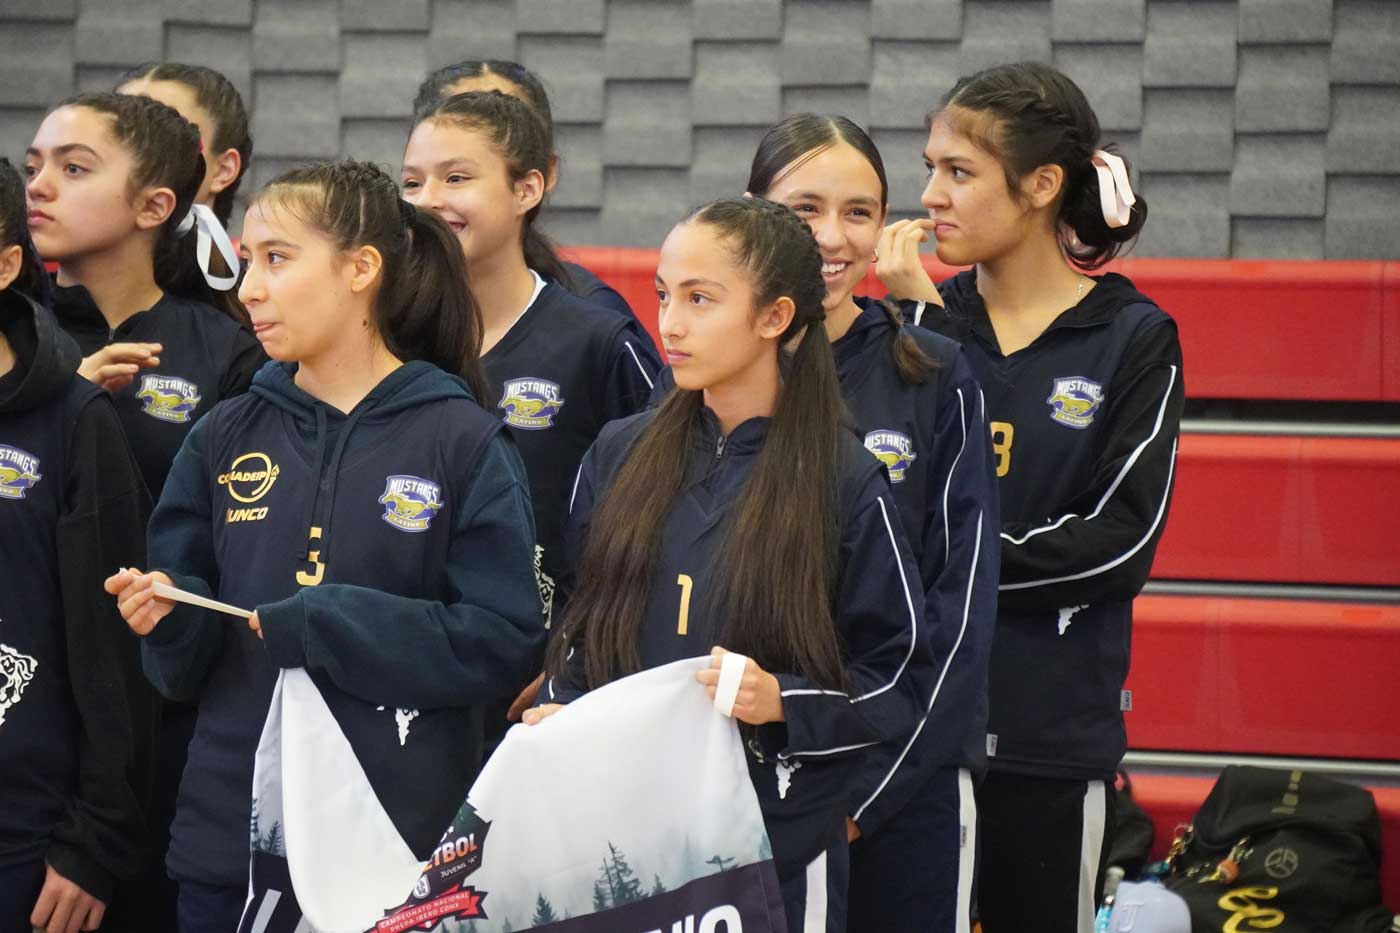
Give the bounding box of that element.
[258,431,545,709]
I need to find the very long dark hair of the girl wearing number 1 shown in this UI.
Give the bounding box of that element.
[550,198,846,689]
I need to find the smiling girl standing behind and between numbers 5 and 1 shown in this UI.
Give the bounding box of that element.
[402,91,661,738]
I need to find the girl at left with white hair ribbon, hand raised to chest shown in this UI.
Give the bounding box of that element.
[24,94,266,497]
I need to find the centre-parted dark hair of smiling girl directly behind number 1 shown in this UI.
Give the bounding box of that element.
[746,113,937,385]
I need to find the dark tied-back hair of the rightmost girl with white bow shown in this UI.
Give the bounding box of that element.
[927,62,1147,270]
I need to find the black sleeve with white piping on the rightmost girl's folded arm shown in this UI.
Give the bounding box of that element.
[1000,318,1186,609]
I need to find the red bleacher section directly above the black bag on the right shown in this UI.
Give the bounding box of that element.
[1126,595,1400,756]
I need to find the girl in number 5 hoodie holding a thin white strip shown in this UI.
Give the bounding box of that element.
[106,161,545,933]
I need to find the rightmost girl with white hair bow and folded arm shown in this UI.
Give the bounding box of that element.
[920,63,1184,933]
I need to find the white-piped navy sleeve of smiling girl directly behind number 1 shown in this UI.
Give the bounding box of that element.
[850,353,1000,835]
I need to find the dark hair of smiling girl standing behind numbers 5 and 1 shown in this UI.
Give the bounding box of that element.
[414,91,573,289]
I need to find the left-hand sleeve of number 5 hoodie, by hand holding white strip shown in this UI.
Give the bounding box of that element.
[141,408,230,700]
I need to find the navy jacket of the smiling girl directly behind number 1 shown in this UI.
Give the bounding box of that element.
[832,298,1000,836]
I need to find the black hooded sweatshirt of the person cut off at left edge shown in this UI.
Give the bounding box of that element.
[0,289,155,902]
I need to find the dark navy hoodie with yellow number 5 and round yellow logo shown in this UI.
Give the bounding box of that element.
[135,363,545,885]
